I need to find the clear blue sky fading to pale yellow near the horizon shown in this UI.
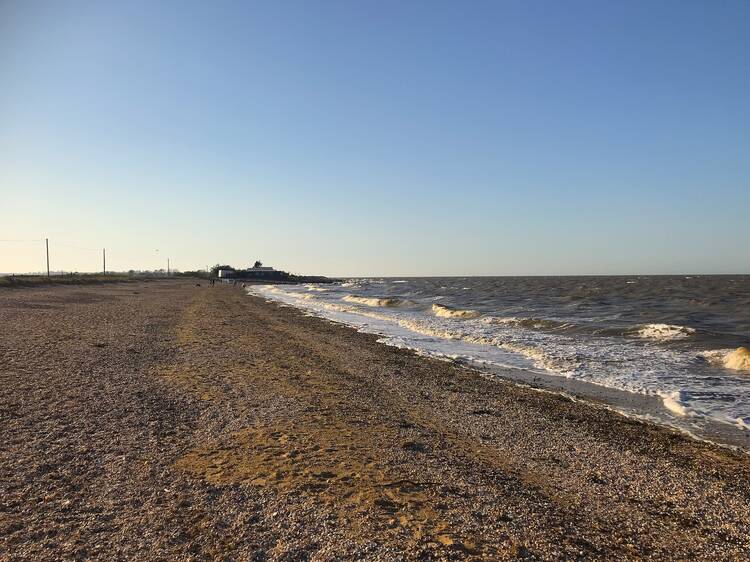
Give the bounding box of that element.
[0,0,750,276]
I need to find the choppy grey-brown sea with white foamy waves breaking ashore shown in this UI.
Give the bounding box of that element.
[247,275,750,449]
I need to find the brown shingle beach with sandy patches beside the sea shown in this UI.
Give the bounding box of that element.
[0,281,750,561]
